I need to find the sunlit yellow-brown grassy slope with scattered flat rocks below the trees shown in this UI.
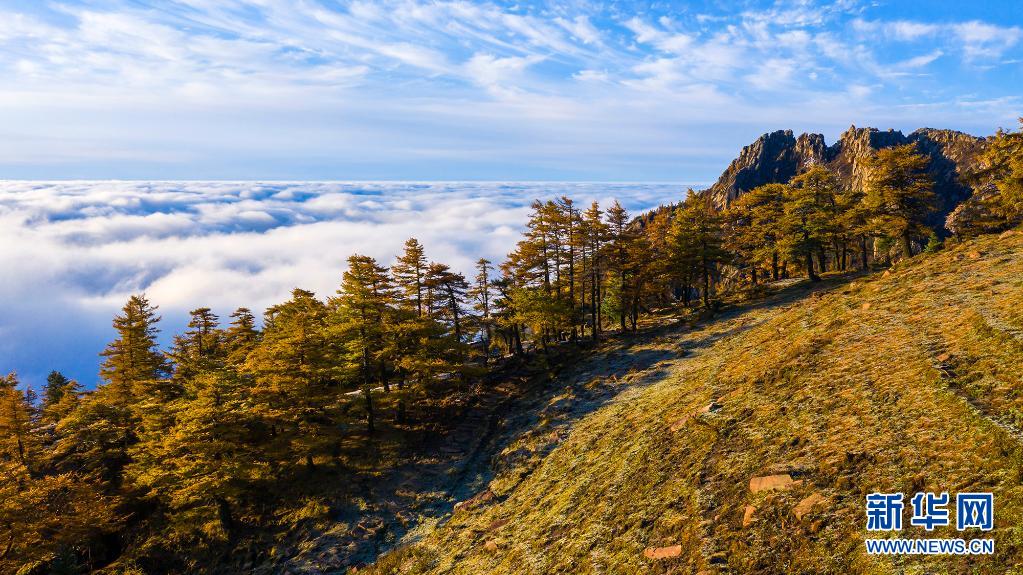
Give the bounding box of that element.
[376,232,1023,575]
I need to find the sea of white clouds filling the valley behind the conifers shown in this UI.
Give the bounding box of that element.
[0,181,686,387]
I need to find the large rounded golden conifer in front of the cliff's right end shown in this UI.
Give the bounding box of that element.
[863,144,935,258]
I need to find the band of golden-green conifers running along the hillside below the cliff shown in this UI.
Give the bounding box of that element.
[0,124,1023,573]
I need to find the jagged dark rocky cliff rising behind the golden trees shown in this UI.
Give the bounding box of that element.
[707,126,986,230]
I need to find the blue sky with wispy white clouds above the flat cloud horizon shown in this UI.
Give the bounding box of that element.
[0,0,1023,182]
